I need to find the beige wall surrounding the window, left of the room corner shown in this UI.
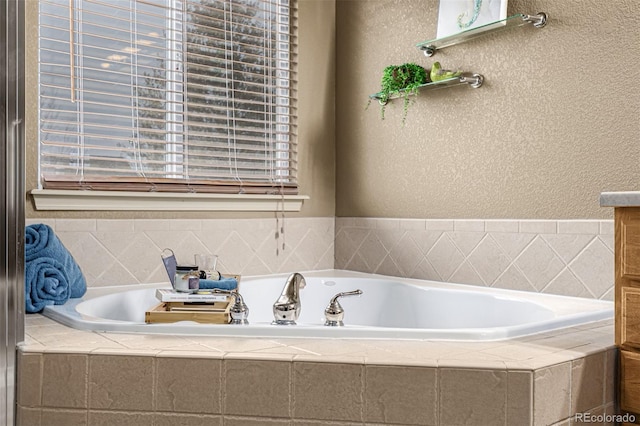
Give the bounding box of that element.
[25,0,335,219]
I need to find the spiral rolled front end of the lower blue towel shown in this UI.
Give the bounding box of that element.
[24,257,70,313]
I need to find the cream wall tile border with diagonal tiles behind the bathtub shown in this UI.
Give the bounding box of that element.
[27,217,614,300]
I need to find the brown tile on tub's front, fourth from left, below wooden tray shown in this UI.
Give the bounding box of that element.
[155,358,222,414]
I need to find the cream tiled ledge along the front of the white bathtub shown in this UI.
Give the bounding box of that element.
[20,314,614,370]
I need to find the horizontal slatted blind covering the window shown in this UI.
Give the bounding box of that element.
[39,0,297,194]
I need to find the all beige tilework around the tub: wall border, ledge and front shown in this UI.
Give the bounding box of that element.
[18,218,616,426]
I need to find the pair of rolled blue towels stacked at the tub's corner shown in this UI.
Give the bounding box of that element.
[24,224,87,312]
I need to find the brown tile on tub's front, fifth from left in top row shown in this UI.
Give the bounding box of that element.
[223,360,291,418]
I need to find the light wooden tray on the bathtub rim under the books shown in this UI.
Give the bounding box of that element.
[144,302,231,324]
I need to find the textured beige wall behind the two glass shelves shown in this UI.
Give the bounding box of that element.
[336,0,640,219]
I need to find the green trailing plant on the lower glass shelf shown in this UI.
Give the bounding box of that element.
[368,63,429,125]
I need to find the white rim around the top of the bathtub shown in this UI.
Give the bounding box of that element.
[44,270,613,341]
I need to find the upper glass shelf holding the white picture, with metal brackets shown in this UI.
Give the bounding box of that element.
[416,12,547,56]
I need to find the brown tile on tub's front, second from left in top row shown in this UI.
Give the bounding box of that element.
[42,354,88,408]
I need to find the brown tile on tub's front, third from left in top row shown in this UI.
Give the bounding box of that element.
[89,355,154,411]
